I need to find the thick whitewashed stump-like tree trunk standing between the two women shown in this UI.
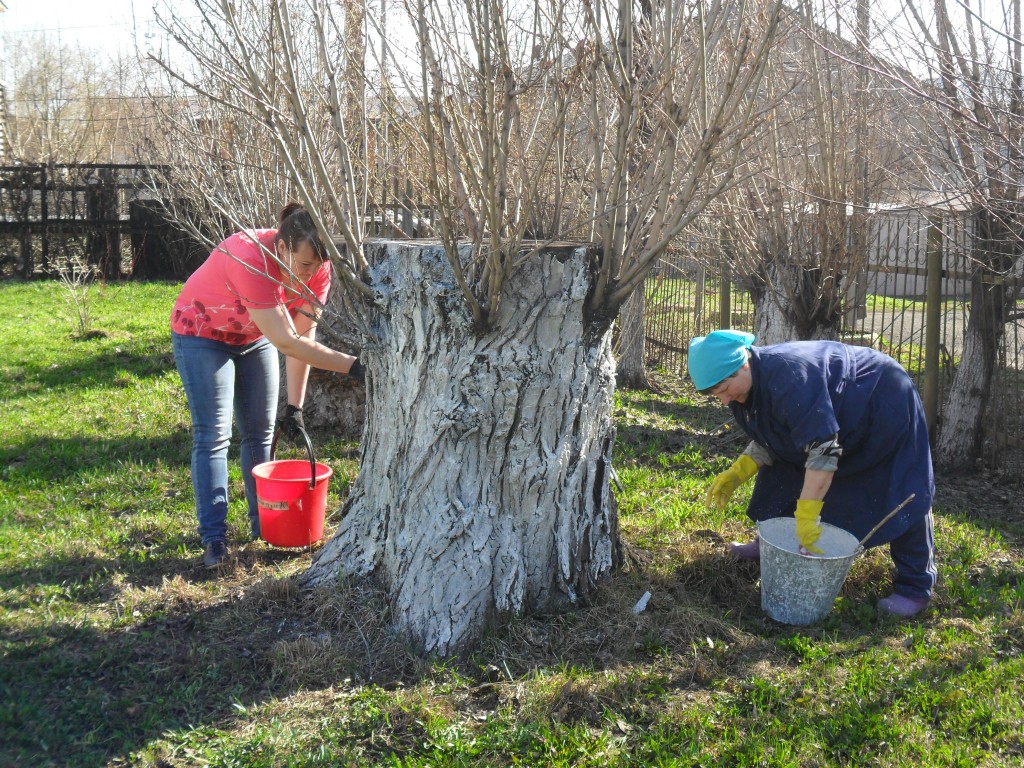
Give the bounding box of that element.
[304,243,621,654]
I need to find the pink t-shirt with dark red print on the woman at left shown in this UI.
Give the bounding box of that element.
[171,229,331,345]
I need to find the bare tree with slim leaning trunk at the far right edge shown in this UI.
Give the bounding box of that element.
[864,0,1024,469]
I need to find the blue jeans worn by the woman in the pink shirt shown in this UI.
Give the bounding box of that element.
[171,332,280,546]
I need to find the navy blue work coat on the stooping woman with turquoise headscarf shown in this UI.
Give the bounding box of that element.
[729,341,935,547]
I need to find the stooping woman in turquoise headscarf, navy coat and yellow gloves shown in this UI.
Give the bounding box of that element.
[688,331,936,616]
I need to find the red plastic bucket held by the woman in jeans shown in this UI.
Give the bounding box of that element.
[253,459,334,547]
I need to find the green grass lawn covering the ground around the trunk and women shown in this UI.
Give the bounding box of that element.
[0,284,1024,768]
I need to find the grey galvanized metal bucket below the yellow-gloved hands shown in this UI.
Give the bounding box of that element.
[758,517,863,625]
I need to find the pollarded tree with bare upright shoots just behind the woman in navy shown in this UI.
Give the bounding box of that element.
[723,0,915,344]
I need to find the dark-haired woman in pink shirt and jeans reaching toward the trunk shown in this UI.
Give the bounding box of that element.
[171,203,362,568]
